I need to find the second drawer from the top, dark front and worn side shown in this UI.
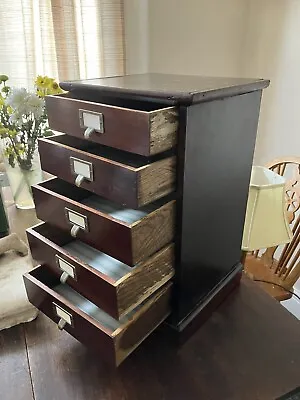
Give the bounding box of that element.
[39,135,175,208]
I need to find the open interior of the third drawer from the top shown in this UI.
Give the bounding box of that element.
[38,178,166,225]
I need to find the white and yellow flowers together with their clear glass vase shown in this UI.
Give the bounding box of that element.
[0,75,62,208]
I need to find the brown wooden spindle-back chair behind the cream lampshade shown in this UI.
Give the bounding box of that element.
[244,157,300,301]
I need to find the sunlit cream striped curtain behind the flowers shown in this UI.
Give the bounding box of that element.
[0,0,124,87]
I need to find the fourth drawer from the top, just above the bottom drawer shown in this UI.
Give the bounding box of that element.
[27,223,174,319]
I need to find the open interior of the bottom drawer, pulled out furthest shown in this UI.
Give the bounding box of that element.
[29,266,166,336]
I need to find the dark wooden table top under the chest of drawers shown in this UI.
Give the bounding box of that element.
[0,205,300,400]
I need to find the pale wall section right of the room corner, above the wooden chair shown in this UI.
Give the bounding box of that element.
[240,0,300,164]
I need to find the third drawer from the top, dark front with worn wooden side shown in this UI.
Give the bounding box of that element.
[32,179,175,266]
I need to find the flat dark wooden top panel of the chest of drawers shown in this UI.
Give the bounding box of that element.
[60,73,270,105]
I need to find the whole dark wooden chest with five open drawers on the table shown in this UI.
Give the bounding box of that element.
[24,74,269,365]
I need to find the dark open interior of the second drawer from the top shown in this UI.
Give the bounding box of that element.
[42,134,174,169]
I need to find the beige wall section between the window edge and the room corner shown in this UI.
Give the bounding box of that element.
[149,0,246,76]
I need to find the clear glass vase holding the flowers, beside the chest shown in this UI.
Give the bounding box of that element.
[3,149,43,210]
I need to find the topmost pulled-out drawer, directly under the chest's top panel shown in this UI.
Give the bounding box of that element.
[46,93,178,156]
